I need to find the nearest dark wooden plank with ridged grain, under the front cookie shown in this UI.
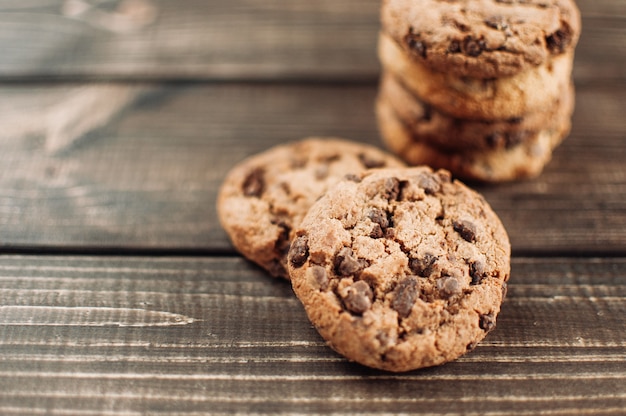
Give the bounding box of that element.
[0,256,626,415]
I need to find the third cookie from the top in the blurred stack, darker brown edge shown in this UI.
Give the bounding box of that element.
[378,71,574,153]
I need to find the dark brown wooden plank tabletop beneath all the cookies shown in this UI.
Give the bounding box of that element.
[0,0,626,415]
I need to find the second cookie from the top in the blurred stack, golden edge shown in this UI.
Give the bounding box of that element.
[378,33,574,120]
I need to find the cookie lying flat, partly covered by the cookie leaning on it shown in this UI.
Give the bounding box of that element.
[217,138,404,279]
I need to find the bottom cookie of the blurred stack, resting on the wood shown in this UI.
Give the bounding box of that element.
[376,100,571,182]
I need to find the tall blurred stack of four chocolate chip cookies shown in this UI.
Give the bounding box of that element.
[376,0,581,182]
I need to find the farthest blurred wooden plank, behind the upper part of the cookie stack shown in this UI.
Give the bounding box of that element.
[0,0,626,81]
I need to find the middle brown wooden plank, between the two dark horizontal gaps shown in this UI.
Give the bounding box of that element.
[0,80,626,254]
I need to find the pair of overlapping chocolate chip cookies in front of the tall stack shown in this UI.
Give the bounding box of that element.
[217,138,511,371]
